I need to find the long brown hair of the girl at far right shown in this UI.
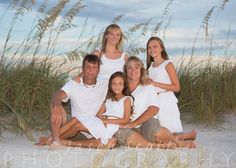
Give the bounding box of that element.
[146,37,169,69]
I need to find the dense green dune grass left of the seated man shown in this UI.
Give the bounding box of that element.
[0,58,65,138]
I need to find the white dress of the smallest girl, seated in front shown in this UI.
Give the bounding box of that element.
[77,96,132,144]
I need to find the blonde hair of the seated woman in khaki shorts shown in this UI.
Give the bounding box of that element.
[124,56,147,85]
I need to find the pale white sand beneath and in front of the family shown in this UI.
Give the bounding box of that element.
[0,114,236,168]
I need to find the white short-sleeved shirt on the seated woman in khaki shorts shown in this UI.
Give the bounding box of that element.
[131,85,159,121]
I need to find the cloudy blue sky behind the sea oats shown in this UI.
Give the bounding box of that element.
[0,0,236,56]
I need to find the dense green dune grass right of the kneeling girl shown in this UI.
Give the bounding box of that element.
[178,56,236,124]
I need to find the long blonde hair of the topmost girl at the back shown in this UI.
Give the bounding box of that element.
[101,24,124,52]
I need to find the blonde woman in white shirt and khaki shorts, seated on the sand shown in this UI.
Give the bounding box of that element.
[116,56,195,148]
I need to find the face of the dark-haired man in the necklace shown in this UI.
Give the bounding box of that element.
[83,61,99,79]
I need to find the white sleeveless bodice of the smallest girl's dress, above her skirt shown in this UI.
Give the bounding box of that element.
[102,96,133,118]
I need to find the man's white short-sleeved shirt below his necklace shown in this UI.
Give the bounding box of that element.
[61,79,107,117]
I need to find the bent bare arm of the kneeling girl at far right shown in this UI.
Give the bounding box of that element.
[152,63,180,92]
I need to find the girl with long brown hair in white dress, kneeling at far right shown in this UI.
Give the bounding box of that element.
[146,37,196,138]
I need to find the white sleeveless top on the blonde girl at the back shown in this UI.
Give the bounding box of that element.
[98,52,125,79]
